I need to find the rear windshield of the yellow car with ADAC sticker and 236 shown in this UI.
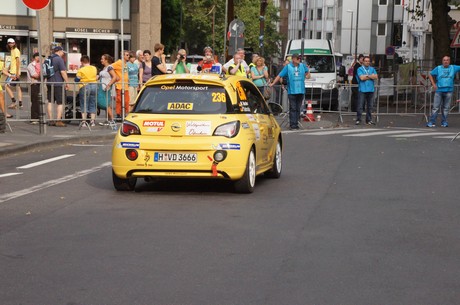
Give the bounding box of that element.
[132,84,232,114]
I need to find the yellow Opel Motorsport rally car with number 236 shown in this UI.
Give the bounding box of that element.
[112,74,283,193]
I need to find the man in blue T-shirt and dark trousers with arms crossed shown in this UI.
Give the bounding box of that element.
[356,56,378,125]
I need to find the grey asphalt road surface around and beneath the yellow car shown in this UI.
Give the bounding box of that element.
[0,128,460,305]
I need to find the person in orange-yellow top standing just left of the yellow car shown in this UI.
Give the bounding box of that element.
[112,51,129,119]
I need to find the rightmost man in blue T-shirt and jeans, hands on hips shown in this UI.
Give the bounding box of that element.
[426,56,460,127]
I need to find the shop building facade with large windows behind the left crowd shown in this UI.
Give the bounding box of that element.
[0,0,161,74]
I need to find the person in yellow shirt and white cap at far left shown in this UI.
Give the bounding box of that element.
[3,38,22,109]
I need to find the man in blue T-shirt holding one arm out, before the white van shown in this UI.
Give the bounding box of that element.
[270,54,310,130]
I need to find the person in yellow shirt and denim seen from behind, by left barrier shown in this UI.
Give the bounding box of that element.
[75,55,97,127]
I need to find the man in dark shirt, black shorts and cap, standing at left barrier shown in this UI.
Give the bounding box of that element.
[46,46,69,127]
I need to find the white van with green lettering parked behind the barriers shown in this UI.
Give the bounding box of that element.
[285,39,345,110]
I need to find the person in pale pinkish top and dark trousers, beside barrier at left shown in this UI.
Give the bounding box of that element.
[27,53,41,124]
